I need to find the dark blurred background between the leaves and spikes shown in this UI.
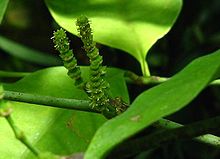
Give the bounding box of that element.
[0,0,220,159]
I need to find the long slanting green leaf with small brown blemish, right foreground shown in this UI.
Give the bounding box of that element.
[85,50,220,159]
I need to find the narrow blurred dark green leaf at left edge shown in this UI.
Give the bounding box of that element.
[0,36,61,66]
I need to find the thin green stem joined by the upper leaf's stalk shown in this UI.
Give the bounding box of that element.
[124,71,220,85]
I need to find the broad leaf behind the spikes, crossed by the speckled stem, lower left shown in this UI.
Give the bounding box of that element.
[0,67,128,159]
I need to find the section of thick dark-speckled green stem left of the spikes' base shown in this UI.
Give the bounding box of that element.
[4,91,94,112]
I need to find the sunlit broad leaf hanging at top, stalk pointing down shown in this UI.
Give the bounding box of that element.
[46,0,182,75]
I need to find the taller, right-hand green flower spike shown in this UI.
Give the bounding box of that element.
[76,16,115,114]
